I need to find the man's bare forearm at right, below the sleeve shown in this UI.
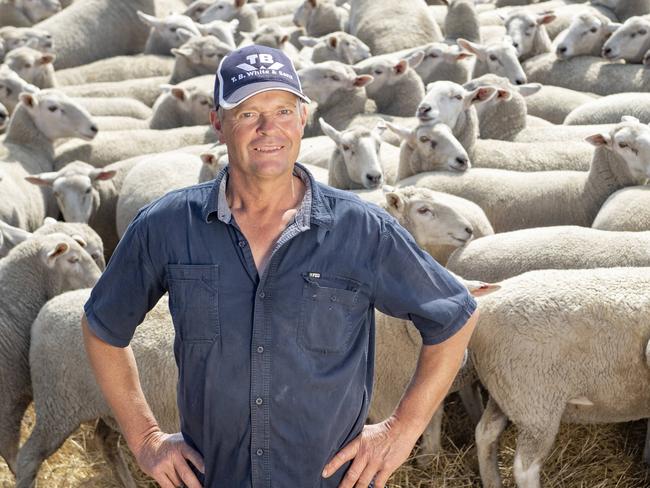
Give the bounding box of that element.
[392,312,478,438]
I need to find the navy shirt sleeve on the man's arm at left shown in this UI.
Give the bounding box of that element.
[84,208,165,347]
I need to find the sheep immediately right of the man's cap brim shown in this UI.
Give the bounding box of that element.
[298,61,373,137]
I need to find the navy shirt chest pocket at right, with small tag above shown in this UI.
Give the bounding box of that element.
[298,273,367,353]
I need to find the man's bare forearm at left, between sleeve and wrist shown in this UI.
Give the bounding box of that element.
[81,315,159,452]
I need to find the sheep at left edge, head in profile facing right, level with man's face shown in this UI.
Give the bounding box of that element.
[0,90,97,230]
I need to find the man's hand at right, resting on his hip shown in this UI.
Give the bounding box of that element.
[323,417,419,488]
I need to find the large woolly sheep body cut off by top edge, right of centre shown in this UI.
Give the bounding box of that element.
[348,0,442,55]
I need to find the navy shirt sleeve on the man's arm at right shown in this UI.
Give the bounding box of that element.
[374,220,476,345]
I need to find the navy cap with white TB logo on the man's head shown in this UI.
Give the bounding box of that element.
[214,44,310,109]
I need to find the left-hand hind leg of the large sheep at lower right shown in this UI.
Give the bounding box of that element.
[476,397,508,488]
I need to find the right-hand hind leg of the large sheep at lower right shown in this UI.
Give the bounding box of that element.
[513,419,560,488]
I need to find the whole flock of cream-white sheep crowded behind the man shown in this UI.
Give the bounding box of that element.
[0,0,650,488]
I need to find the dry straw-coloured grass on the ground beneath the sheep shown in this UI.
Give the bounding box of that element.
[0,396,650,488]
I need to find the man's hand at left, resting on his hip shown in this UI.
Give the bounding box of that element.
[134,431,205,488]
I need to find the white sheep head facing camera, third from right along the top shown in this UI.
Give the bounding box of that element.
[505,9,555,61]
